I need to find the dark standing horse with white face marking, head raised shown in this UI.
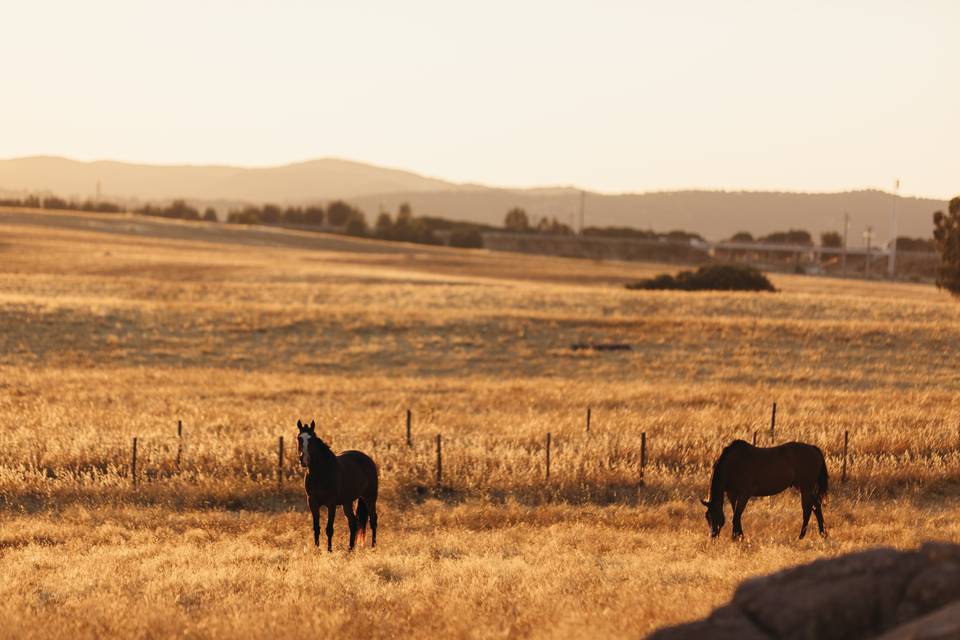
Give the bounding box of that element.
[297,420,379,551]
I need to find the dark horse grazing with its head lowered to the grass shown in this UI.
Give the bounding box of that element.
[700,440,827,540]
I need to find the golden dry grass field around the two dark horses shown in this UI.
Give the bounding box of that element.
[0,211,960,638]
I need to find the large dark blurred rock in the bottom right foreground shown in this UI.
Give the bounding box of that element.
[650,543,960,640]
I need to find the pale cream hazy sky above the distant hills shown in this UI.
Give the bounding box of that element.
[0,0,960,198]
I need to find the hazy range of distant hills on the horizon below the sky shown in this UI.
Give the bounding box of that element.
[0,157,946,245]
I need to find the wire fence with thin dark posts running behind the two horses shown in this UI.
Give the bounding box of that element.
[7,403,960,487]
